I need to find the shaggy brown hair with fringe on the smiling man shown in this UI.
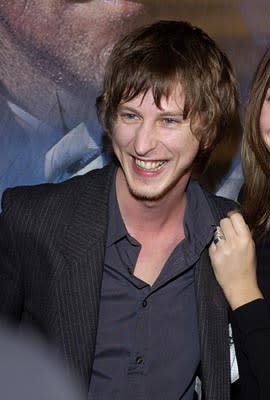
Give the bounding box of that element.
[96,21,238,171]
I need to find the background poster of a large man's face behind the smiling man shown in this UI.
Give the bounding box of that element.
[0,0,270,203]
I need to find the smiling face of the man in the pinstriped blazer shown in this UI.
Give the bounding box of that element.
[112,84,199,201]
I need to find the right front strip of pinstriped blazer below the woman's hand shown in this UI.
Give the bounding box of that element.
[195,245,230,400]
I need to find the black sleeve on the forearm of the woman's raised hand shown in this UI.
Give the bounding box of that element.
[232,299,270,400]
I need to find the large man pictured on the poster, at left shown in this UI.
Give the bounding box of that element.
[0,0,144,197]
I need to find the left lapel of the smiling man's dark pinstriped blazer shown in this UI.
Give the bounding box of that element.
[56,167,114,387]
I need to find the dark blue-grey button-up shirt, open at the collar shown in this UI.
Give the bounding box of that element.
[89,175,213,400]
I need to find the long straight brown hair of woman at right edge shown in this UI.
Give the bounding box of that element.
[242,48,270,240]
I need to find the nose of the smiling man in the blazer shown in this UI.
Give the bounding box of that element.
[134,122,158,156]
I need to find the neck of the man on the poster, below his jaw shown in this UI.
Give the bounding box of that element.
[0,25,98,133]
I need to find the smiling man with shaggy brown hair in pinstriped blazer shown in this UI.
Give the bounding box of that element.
[0,21,238,400]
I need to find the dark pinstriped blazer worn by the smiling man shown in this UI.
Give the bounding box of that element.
[0,166,235,400]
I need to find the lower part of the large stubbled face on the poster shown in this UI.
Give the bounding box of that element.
[0,0,144,86]
